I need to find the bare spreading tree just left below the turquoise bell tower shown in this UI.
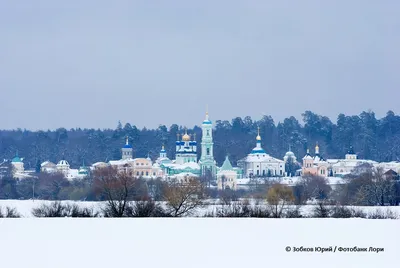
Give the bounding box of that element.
[164,178,204,217]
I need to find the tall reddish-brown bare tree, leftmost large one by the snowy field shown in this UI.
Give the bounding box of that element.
[94,167,136,217]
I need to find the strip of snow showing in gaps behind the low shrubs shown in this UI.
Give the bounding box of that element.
[0,200,400,220]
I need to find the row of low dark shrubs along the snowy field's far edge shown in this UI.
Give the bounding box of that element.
[0,200,399,220]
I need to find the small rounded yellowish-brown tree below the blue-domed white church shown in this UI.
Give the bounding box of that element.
[267,184,294,218]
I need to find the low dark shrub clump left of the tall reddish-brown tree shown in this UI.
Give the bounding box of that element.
[32,201,99,218]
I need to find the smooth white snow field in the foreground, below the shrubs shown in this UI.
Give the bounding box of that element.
[0,218,400,268]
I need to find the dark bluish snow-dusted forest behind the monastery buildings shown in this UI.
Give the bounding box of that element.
[0,111,400,169]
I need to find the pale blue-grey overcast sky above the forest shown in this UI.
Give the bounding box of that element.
[0,0,400,130]
